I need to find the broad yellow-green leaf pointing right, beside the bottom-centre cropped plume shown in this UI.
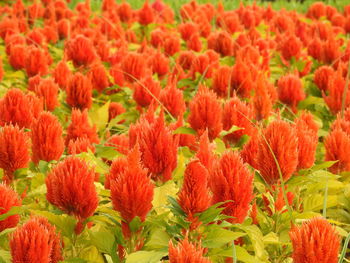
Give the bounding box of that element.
[202,225,246,248]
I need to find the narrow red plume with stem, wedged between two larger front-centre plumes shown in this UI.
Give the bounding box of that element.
[178,161,211,229]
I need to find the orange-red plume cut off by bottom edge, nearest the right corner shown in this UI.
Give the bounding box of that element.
[289,217,340,263]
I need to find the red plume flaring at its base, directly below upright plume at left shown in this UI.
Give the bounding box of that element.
[66,109,99,145]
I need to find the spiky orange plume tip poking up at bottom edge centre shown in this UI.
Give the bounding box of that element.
[169,238,211,263]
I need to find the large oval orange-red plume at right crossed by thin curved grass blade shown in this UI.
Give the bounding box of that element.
[257,120,298,185]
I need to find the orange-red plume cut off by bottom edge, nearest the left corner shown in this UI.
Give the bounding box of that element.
[10,217,63,263]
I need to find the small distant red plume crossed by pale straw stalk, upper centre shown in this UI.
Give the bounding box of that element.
[133,75,162,107]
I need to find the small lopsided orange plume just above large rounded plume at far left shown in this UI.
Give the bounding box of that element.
[34,78,59,111]
